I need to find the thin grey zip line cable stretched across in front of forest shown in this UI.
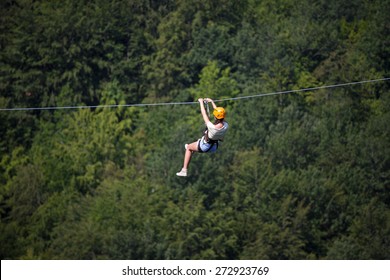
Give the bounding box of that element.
[0,78,390,111]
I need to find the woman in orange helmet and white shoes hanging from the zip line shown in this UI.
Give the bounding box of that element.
[176,98,229,177]
